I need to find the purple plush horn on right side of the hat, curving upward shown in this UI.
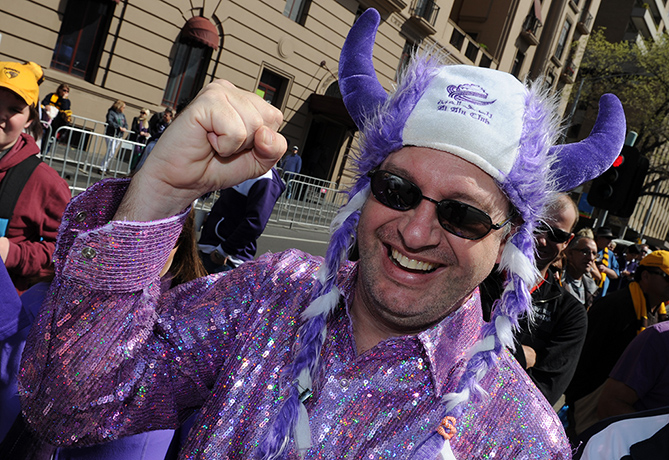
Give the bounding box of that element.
[550,94,626,192]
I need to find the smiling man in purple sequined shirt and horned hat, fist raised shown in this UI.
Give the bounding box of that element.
[21,9,625,459]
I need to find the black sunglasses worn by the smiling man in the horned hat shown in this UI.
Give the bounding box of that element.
[367,170,513,240]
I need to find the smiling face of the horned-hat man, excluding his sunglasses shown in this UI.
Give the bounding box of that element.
[352,147,509,335]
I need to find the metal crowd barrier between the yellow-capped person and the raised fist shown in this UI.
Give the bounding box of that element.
[42,126,144,196]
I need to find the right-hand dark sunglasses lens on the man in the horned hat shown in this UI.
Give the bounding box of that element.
[437,200,492,240]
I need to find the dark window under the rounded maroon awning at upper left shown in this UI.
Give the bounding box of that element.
[163,38,212,107]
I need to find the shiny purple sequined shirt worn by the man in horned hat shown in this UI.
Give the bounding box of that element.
[20,181,571,460]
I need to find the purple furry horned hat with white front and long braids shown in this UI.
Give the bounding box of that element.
[261,9,625,459]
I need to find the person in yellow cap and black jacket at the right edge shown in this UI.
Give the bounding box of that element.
[567,251,669,434]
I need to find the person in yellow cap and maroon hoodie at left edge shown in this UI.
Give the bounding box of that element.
[0,62,71,292]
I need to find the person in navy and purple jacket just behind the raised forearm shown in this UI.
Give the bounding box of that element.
[198,168,286,273]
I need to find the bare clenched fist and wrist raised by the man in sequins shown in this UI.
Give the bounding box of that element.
[114,80,286,221]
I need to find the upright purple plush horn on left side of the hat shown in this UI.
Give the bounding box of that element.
[339,8,388,128]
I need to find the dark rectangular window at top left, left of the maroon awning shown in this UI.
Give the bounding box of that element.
[51,0,115,81]
